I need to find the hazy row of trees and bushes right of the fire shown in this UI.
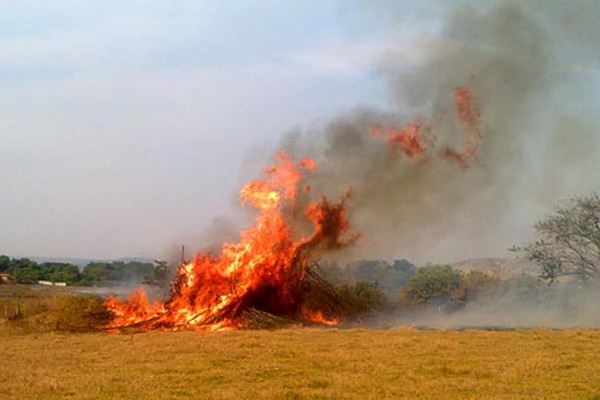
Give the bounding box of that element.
[321,260,545,314]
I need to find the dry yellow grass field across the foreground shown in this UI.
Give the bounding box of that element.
[0,328,600,399]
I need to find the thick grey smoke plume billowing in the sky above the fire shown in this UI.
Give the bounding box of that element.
[282,2,600,262]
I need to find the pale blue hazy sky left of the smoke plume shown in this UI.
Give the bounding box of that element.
[0,0,598,258]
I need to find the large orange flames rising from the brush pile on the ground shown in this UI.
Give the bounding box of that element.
[107,153,357,330]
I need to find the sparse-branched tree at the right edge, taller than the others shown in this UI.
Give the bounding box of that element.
[512,193,600,282]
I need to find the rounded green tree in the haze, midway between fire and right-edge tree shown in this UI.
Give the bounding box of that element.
[402,265,461,305]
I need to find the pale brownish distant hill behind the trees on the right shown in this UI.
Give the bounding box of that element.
[452,258,540,279]
